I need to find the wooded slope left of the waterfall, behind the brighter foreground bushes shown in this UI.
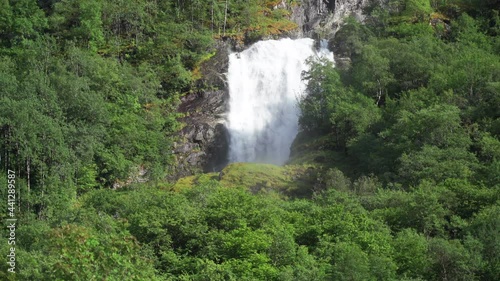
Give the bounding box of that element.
[0,0,294,218]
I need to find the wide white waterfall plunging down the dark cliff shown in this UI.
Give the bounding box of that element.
[228,38,333,165]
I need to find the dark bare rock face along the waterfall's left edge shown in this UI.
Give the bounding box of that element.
[173,42,229,178]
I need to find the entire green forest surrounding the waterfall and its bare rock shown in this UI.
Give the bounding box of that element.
[0,0,500,281]
